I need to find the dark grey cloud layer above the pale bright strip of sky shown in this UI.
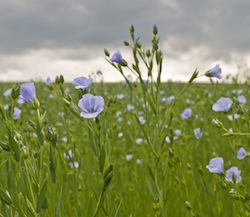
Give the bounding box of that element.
[0,0,250,80]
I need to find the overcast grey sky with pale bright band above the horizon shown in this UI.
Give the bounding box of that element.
[0,0,250,81]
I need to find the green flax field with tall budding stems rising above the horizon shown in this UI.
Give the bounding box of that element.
[0,27,250,217]
